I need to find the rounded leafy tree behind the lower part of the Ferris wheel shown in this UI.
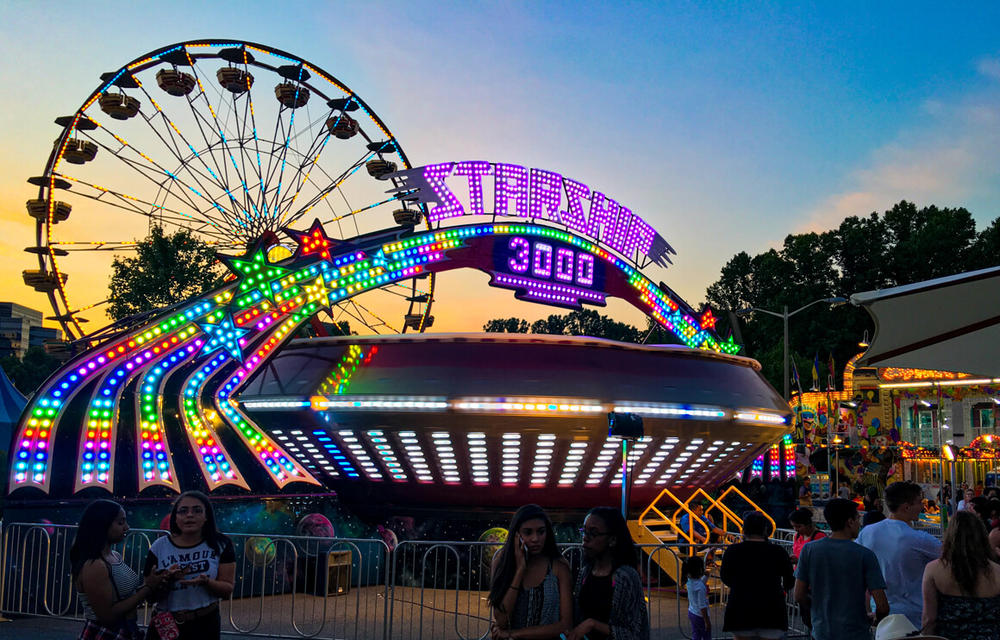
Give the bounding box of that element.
[108,226,223,320]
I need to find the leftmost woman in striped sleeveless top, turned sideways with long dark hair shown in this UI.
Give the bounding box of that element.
[69,500,163,640]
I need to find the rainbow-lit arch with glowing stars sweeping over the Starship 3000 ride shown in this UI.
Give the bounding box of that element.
[9,220,739,493]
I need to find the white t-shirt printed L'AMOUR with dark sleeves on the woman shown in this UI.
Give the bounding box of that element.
[144,536,236,611]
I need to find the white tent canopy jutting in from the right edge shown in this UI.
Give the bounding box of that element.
[851,267,1000,378]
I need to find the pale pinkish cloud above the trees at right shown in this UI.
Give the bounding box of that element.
[795,78,1000,233]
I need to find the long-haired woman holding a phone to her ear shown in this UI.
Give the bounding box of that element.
[488,504,573,640]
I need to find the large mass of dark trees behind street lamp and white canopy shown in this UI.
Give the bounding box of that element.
[705,200,1000,389]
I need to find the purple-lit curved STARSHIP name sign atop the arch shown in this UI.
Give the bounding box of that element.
[387,160,675,266]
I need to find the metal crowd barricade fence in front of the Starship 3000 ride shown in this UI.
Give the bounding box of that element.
[0,523,803,640]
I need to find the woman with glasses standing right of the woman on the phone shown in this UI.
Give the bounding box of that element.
[566,507,649,640]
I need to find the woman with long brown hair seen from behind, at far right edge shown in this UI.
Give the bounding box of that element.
[922,511,1000,640]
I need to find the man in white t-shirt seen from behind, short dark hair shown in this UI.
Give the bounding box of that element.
[858,482,941,629]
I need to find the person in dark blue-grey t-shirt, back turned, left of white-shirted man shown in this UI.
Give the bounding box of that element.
[795,498,889,640]
